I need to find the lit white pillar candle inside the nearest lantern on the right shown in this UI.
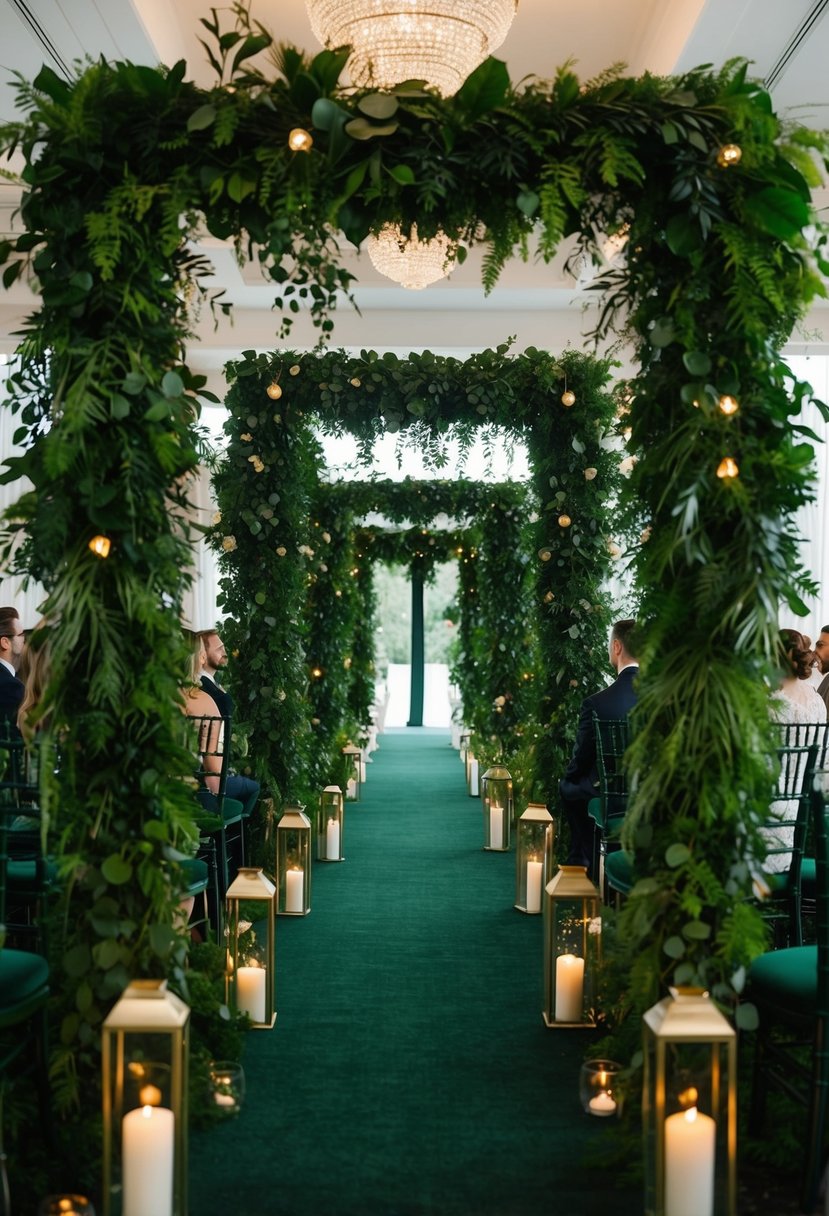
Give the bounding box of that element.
[665,1107,716,1216]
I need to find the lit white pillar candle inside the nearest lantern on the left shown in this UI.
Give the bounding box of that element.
[122,1107,175,1216]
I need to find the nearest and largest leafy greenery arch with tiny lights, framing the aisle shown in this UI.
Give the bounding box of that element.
[0,6,827,1172]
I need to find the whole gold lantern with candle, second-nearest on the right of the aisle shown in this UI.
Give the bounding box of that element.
[543,866,602,1028]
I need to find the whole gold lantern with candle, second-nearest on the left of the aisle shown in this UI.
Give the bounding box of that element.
[225,866,276,1030]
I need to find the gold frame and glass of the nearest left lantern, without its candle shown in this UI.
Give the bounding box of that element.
[101,979,190,1216]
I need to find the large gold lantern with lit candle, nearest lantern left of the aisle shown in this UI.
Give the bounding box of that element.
[101,980,190,1216]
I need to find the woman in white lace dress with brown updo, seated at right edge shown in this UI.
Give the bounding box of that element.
[763,629,827,873]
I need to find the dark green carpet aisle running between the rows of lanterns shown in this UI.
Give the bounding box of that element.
[190,730,641,1216]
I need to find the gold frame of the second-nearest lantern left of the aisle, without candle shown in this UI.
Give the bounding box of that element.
[225,866,276,1030]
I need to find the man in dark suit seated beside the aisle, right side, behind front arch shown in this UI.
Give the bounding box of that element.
[559,620,639,871]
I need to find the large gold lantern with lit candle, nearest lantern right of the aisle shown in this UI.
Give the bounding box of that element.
[642,987,737,1216]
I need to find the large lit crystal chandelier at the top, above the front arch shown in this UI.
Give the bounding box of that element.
[306,0,518,97]
